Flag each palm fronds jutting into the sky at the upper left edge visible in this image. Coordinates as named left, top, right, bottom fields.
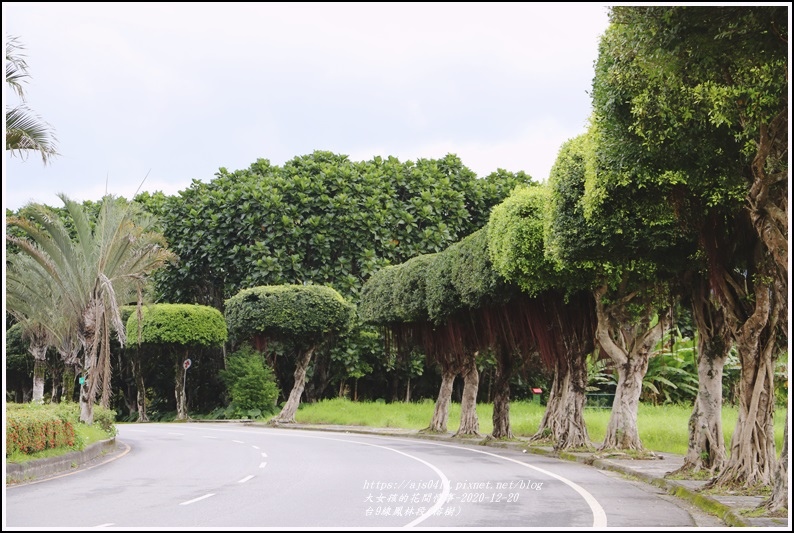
left=6, top=36, right=58, bottom=165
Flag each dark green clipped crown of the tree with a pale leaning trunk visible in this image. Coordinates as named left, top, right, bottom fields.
left=226, top=285, right=356, bottom=347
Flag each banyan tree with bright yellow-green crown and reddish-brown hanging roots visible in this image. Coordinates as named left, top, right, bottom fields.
left=487, top=187, right=596, bottom=449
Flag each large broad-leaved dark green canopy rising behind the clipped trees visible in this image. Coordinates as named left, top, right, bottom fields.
left=144, top=151, right=530, bottom=309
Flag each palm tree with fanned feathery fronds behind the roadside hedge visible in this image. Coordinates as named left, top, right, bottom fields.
left=6, top=194, right=175, bottom=424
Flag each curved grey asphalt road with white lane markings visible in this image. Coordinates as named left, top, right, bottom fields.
left=4, top=423, right=712, bottom=529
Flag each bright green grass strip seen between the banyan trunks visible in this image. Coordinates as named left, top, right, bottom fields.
left=295, top=398, right=786, bottom=455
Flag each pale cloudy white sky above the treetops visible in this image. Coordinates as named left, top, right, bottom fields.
left=2, top=2, right=608, bottom=210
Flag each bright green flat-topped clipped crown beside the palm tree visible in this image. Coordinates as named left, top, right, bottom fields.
left=127, top=304, right=228, bottom=346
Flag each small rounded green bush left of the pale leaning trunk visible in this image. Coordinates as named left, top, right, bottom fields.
left=220, top=344, right=279, bottom=418
